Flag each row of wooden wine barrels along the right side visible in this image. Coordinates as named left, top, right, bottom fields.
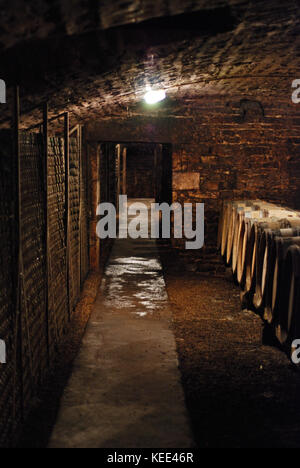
left=218, top=200, right=300, bottom=356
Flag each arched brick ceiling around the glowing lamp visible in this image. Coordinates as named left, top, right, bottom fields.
left=0, top=0, right=300, bottom=127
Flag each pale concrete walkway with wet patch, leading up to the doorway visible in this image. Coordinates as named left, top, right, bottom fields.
left=49, top=199, right=193, bottom=448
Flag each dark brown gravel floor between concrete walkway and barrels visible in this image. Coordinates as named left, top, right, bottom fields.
left=161, top=243, right=300, bottom=448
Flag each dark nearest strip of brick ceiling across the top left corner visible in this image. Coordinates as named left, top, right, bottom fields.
left=0, top=0, right=242, bottom=48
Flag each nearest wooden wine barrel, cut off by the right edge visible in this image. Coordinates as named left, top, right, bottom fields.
left=276, top=243, right=300, bottom=346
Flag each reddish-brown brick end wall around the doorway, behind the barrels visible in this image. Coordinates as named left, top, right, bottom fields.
left=87, top=94, right=300, bottom=252
